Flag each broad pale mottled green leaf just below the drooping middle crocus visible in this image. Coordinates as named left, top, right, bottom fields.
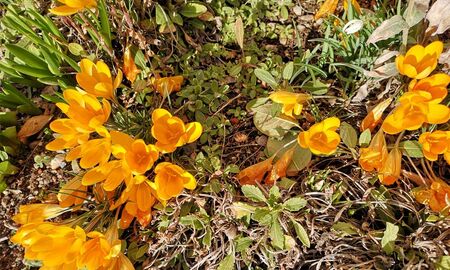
left=252, top=104, right=298, bottom=138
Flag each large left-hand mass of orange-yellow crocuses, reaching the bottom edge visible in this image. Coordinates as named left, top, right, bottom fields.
left=13, top=59, right=202, bottom=270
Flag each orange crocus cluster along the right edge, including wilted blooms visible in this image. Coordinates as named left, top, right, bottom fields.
left=359, top=41, right=450, bottom=211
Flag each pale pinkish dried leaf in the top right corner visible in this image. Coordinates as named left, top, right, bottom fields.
left=426, top=0, right=450, bottom=35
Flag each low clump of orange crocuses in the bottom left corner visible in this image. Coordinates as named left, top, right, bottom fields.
left=11, top=220, right=134, bottom=270
